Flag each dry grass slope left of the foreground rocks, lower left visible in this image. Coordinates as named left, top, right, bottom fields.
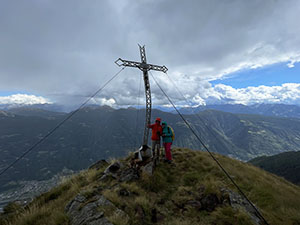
left=0, top=170, right=105, bottom=225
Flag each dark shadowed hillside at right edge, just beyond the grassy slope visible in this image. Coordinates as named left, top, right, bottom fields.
left=249, top=152, right=300, bottom=185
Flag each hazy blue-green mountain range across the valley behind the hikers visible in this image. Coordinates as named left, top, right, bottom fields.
left=0, top=106, right=300, bottom=191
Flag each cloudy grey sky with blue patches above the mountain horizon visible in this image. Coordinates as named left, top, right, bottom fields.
left=0, top=0, right=300, bottom=106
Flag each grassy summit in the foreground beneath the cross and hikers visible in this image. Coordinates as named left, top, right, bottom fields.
left=0, top=149, right=300, bottom=225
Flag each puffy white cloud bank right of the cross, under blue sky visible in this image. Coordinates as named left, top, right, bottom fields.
left=152, top=78, right=300, bottom=106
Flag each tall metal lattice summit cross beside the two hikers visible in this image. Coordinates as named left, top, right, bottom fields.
left=115, top=45, right=168, bottom=146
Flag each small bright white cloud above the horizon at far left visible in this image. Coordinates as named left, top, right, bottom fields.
left=0, top=94, right=52, bottom=105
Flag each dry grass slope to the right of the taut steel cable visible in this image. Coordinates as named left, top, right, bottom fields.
left=214, top=153, right=300, bottom=224
